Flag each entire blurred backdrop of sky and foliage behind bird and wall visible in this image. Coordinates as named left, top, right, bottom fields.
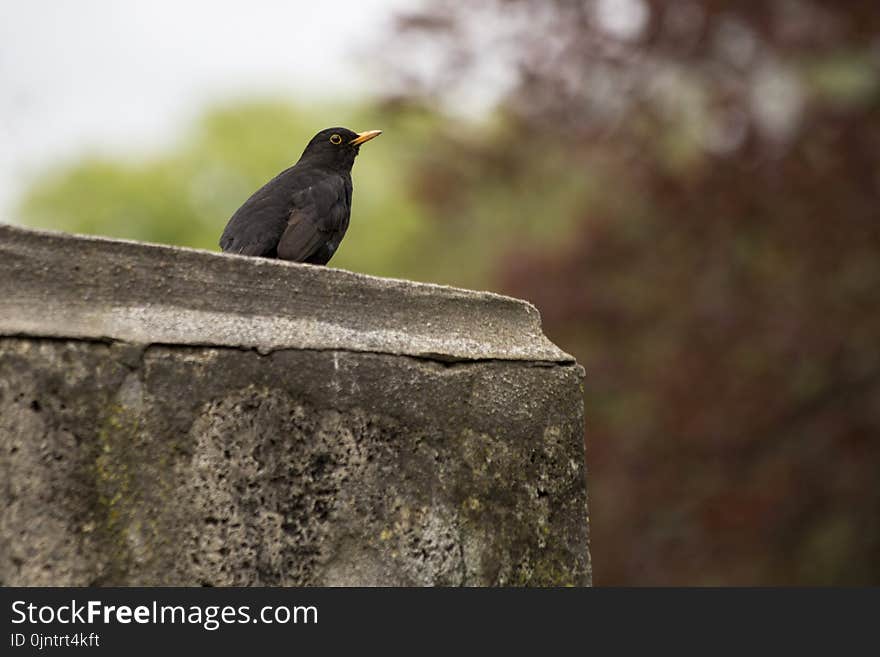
left=0, top=0, right=880, bottom=585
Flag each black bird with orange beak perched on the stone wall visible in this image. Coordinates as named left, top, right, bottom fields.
left=220, top=128, right=382, bottom=265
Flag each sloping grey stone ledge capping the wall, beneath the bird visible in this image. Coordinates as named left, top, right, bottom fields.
left=0, top=225, right=574, bottom=364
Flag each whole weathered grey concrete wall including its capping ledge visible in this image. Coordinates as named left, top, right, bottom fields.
left=0, top=226, right=590, bottom=585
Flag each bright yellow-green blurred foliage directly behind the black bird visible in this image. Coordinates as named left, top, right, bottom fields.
left=20, top=102, right=438, bottom=276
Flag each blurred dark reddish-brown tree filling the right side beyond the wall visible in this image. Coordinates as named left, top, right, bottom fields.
left=387, top=0, right=880, bottom=584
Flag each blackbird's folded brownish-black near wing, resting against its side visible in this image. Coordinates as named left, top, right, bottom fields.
left=278, top=177, right=348, bottom=262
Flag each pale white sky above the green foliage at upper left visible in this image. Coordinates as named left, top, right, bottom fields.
left=0, top=0, right=419, bottom=221
